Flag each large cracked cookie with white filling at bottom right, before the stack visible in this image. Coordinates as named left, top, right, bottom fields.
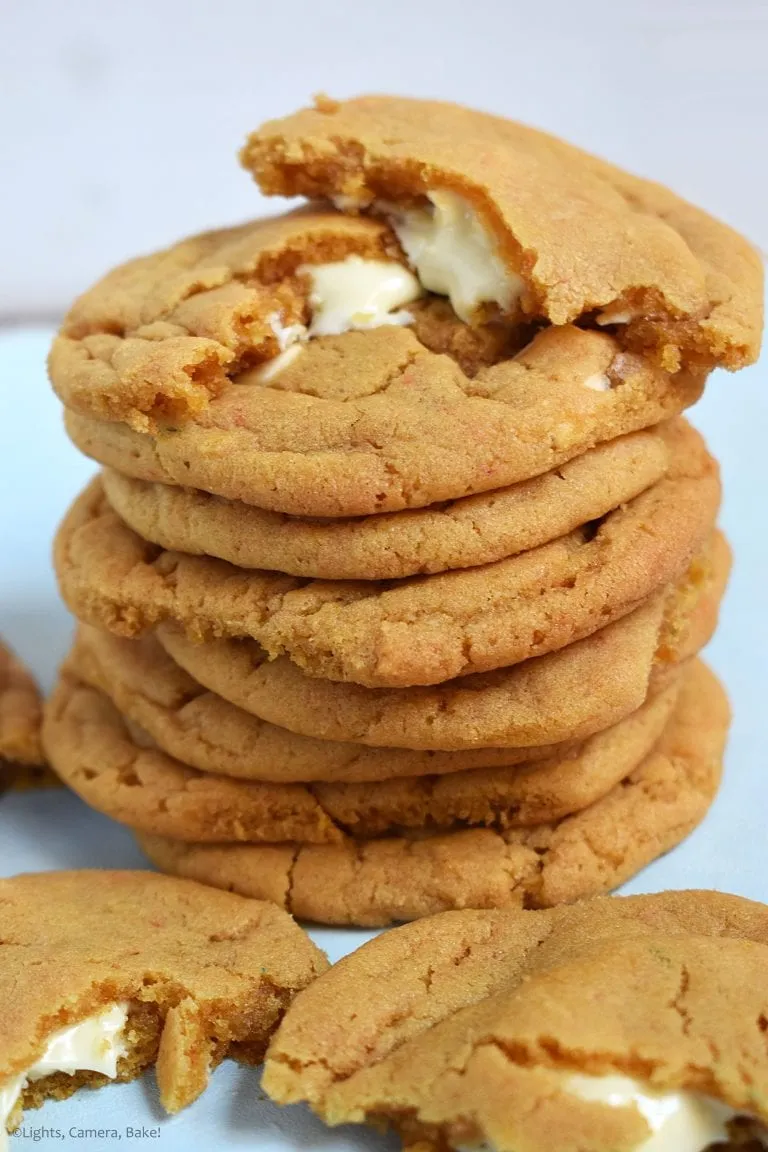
left=264, top=892, right=768, bottom=1152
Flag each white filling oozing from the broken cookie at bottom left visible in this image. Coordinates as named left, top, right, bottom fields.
left=0, top=1005, right=128, bottom=1152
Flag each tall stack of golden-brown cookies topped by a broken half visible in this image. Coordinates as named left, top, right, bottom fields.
left=44, top=98, right=761, bottom=924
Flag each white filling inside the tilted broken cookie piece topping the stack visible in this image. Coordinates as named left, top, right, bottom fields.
left=379, top=190, right=524, bottom=323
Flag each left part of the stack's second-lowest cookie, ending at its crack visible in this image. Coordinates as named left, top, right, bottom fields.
left=43, top=667, right=342, bottom=843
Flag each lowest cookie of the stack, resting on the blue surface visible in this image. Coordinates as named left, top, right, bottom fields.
left=139, top=665, right=729, bottom=926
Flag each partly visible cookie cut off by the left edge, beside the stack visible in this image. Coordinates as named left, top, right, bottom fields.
left=0, top=643, right=58, bottom=791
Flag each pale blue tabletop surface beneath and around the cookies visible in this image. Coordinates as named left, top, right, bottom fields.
left=0, top=331, right=768, bottom=1152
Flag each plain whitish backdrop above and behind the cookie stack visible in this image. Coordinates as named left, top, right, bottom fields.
left=0, top=0, right=768, bottom=320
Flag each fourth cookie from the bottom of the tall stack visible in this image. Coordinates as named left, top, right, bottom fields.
left=157, top=535, right=730, bottom=751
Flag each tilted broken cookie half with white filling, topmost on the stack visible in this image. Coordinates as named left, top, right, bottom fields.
left=241, top=96, right=762, bottom=367
